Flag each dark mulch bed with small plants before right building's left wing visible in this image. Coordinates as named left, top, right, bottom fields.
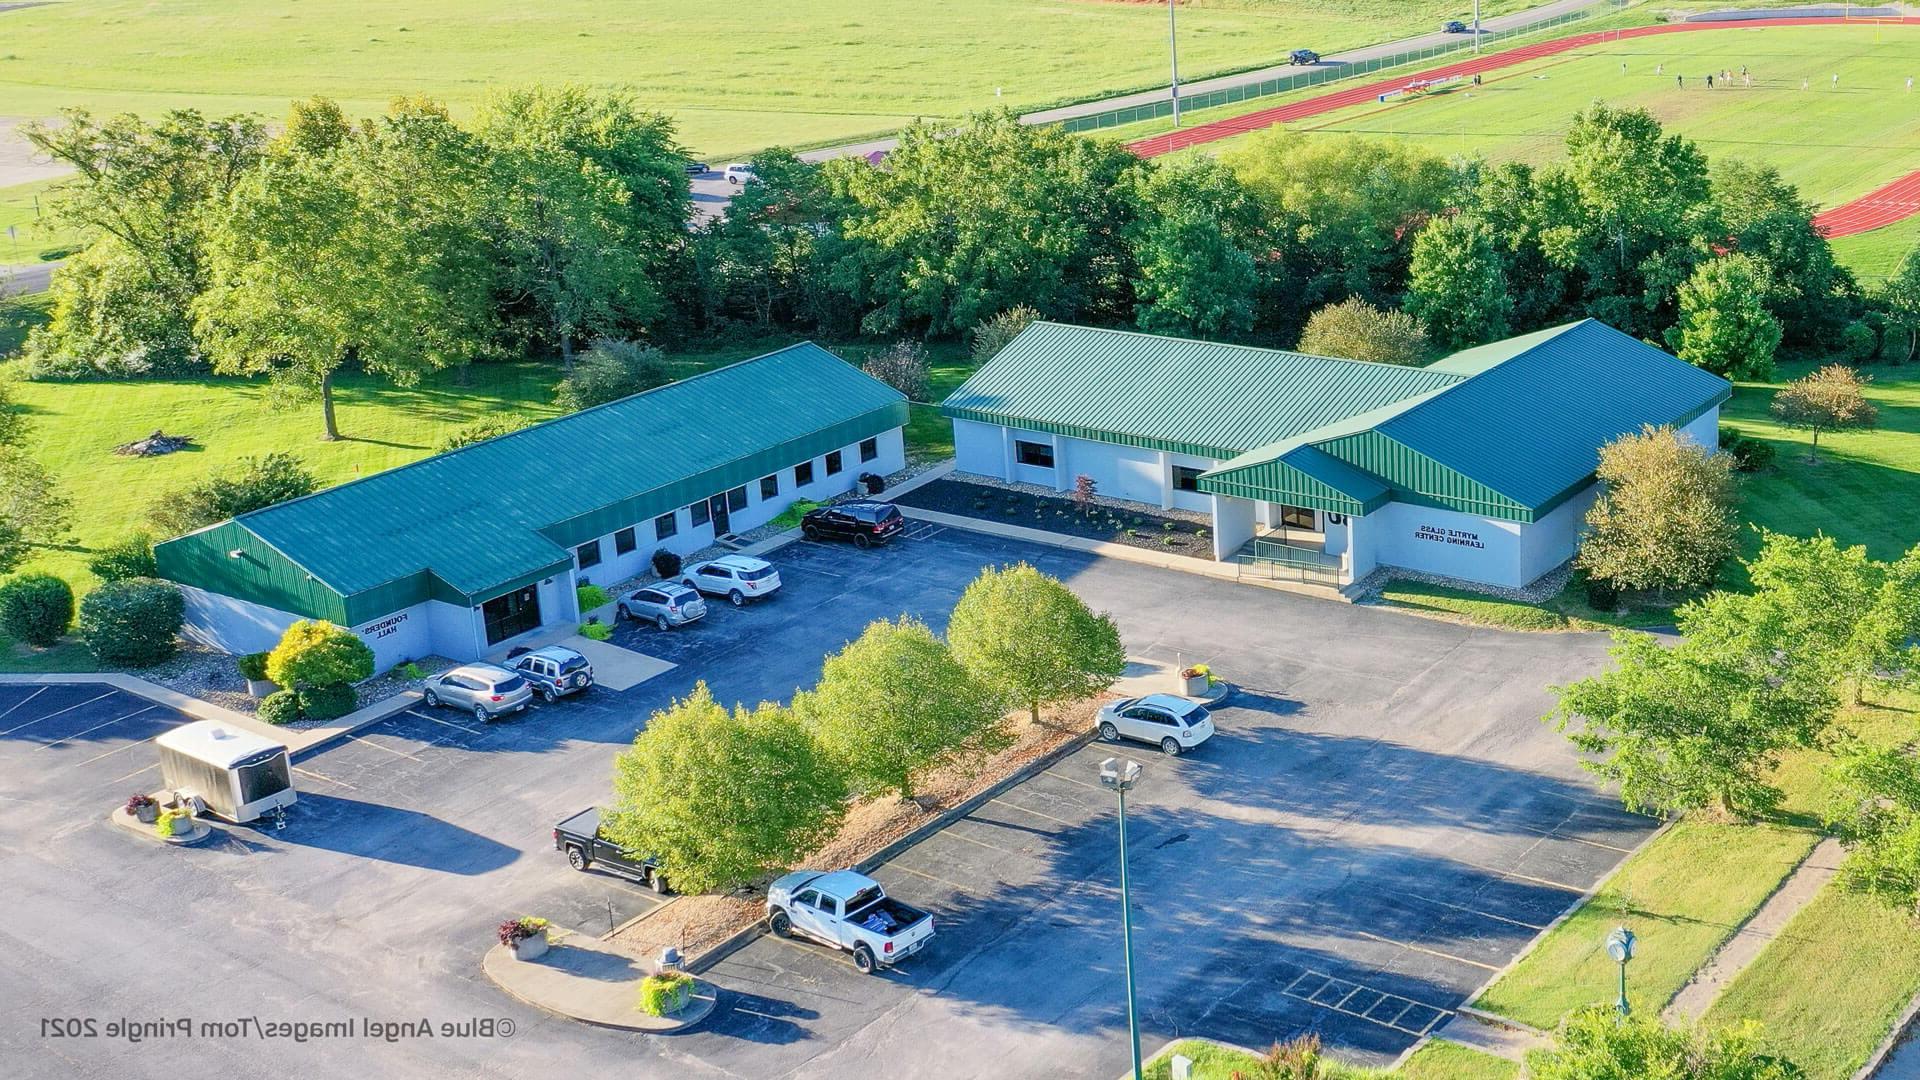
left=893, top=479, right=1213, bottom=559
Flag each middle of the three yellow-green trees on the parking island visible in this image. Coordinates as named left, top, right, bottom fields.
left=793, top=615, right=1008, bottom=799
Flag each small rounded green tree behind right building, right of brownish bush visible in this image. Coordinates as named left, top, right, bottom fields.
left=1405, top=213, right=1513, bottom=350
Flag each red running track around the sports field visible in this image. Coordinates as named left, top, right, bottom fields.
left=1127, top=15, right=1920, bottom=236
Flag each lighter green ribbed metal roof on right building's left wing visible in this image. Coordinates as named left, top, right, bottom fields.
left=941, top=323, right=1461, bottom=457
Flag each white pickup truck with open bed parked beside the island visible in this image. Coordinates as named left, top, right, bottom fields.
left=766, top=871, right=933, bottom=974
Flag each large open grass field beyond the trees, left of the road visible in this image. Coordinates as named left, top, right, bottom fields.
left=0, top=0, right=1526, bottom=156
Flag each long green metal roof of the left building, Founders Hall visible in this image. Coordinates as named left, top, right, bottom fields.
left=161, top=342, right=906, bottom=621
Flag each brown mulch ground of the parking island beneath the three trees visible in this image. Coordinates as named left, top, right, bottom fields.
left=614, top=698, right=1106, bottom=959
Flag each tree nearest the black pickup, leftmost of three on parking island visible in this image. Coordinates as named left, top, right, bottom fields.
left=601, top=682, right=847, bottom=892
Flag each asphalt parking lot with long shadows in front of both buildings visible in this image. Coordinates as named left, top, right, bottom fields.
left=0, top=527, right=1649, bottom=1078
